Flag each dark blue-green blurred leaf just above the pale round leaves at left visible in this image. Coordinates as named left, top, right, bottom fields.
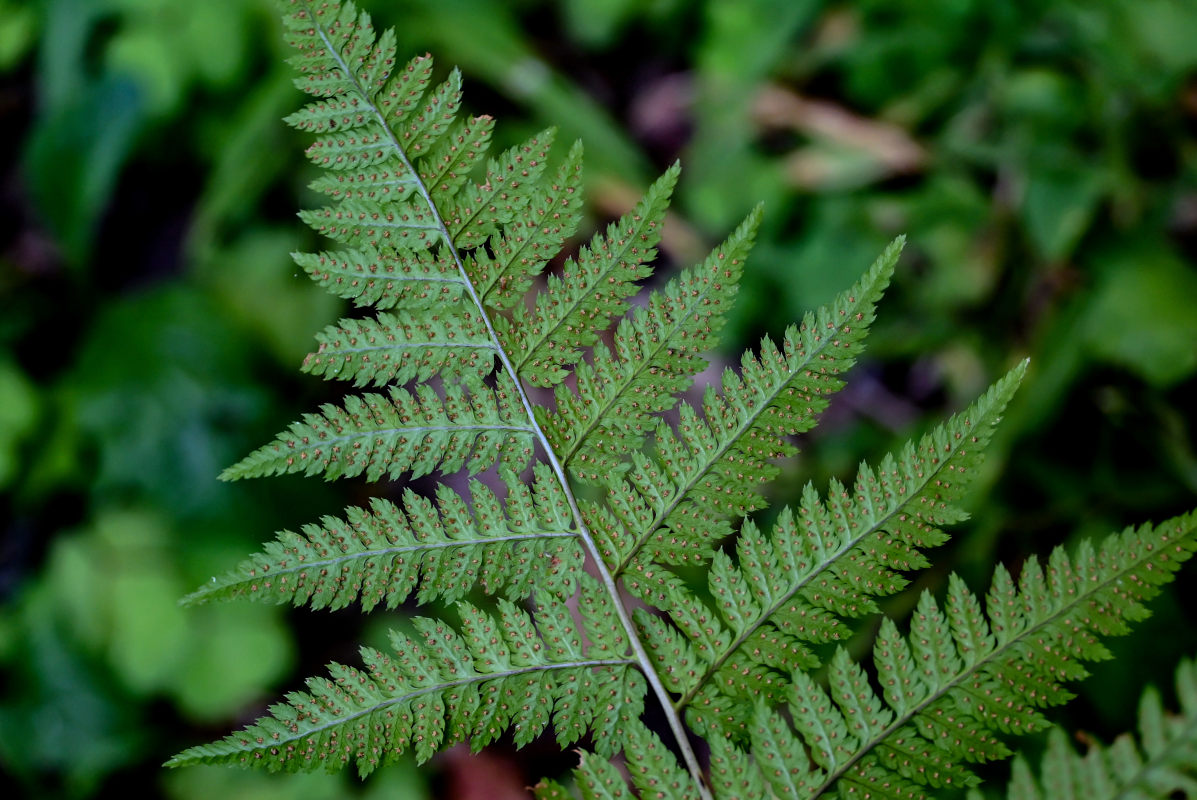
left=63, top=286, right=265, bottom=515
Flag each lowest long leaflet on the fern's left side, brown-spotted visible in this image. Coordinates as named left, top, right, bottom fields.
left=169, top=581, right=645, bottom=775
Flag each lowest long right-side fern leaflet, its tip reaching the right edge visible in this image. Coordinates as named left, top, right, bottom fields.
left=703, top=513, right=1197, bottom=798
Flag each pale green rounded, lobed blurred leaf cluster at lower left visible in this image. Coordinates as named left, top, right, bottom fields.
left=19, top=509, right=294, bottom=721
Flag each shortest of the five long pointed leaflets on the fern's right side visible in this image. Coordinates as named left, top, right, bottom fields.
left=496, top=164, right=679, bottom=386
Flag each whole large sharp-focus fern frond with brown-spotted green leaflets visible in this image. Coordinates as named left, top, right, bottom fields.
left=170, top=0, right=1197, bottom=798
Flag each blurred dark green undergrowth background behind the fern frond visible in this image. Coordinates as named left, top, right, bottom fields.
left=0, top=0, right=1197, bottom=800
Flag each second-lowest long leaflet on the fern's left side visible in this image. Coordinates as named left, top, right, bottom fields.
left=184, top=465, right=583, bottom=611
